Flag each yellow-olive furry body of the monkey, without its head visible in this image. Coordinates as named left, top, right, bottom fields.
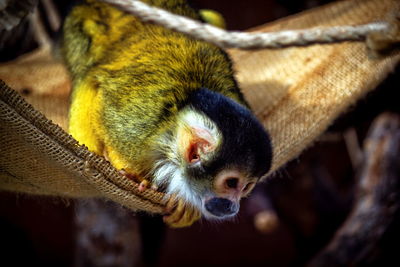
left=62, top=0, right=244, bottom=176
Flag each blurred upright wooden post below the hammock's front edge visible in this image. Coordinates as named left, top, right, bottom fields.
left=74, top=199, right=142, bottom=267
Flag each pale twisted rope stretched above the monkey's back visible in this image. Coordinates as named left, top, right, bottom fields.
left=103, top=0, right=390, bottom=49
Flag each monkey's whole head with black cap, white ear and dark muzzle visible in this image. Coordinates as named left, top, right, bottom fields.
left=152, top=88, right=272, bottom=218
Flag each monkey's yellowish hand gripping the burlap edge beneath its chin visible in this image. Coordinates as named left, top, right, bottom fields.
left=164, top=196, right=201, bottom=228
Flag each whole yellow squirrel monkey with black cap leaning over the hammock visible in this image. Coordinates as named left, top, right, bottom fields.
left=62, top=0, right=272, bottom=227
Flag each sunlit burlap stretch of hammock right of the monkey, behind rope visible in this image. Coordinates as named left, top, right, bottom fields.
left=229, top=0, right=400, bottom=175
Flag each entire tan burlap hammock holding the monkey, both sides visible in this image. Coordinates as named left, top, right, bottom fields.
left=0, top=0, right=400, bottom=213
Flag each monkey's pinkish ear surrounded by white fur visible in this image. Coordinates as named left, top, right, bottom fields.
left=178, top=126, right=216, bottom=163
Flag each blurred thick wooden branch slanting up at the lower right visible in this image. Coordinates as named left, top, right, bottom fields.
left=308, top=114, right=400, bottom=267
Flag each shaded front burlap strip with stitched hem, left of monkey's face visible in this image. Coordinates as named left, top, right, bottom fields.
left=0, top=82, right=166, bottom=213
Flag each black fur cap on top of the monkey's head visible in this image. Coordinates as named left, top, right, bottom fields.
left=189, top=88, right=272, bottom=177
